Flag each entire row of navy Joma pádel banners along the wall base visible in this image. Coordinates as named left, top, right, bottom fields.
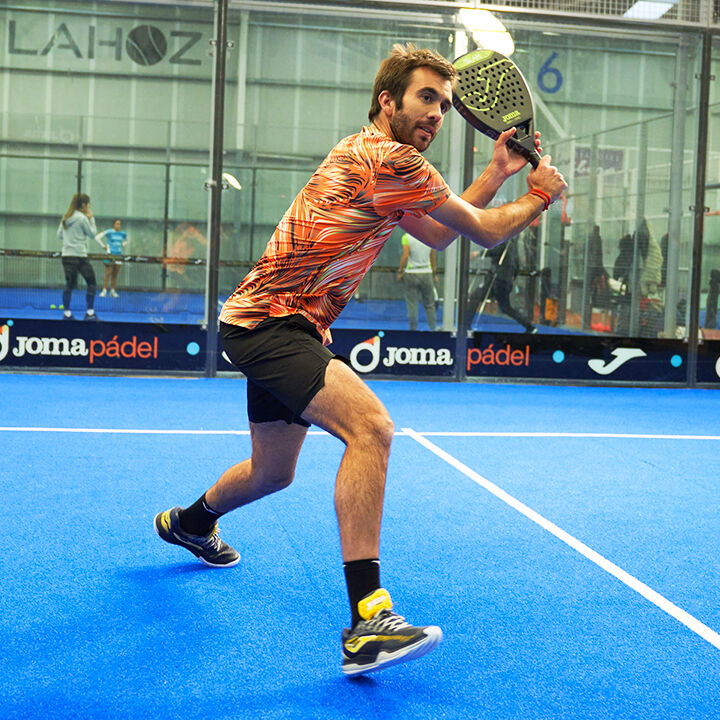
left=0, top=319, right=704, bottom=385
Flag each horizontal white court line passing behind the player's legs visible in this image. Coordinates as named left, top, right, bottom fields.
left=0, top=425, right=720, bottom=440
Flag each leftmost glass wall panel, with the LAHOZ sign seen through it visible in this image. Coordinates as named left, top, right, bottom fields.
left=0, top=0, right=213, bottom=323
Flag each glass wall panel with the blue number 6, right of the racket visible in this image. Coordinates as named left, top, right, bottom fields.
left=458, top=23, right=699, bottom=338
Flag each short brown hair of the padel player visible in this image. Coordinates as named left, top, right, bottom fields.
left=368, top=43, right=457, bottom=122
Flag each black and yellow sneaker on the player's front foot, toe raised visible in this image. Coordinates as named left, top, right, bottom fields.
left=342, top=588, right=442, bottom=675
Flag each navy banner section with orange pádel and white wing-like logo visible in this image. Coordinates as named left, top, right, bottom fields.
left=465, top=333, right=687, bottom=384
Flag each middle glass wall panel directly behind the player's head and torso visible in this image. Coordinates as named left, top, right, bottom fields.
left=220, top=12, right=462, bottom=330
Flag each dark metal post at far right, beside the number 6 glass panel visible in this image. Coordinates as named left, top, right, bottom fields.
left=687, top=30, right=713, bottom=387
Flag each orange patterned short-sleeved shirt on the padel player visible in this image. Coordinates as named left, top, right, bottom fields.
left=220, top=127, right=450, bottom=344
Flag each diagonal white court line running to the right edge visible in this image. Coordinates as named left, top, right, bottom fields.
left=403, top=428, right=720, bottom=650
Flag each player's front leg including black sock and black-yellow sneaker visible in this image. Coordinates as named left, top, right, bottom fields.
left=303, top=360, right=442, bottom=676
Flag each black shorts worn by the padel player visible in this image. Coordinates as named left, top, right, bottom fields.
left=219, top=315, right=335, bottom=427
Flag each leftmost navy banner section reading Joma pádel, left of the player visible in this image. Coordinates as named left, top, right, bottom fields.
left=0, top=319, right=206, bottom=371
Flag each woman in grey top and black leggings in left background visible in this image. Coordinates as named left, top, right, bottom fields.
left=58, top=193, right=98, bottom=320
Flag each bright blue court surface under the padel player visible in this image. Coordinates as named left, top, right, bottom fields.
left=0, top=374, right=720, bottom=720
